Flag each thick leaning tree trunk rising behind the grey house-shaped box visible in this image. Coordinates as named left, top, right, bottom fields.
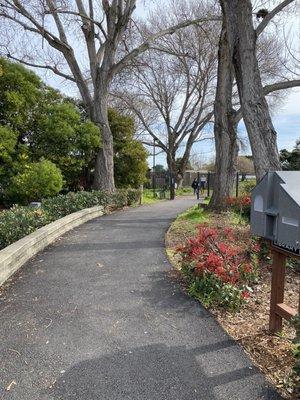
left=220, top=0, right=281, bottom=179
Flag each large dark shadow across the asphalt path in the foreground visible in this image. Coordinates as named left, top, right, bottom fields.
left=49, top=340, right=277, bottom=400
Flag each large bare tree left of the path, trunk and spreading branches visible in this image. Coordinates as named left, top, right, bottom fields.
left=0, top=0, right=220, bottom=191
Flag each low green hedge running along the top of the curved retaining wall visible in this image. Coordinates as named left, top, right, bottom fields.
left=0, top=189, right=141, bottom=249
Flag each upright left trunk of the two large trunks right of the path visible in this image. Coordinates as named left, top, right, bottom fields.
left=209, top=22, right=238, bottom=211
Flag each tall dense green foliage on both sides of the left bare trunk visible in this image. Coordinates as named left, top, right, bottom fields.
left=0, top=58, right=148, bottom=205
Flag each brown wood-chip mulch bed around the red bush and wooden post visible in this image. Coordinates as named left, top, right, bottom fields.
left=166, top=214, right=300, bottom=399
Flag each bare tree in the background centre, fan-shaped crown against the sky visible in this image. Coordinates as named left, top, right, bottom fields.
left=115, top=3, right=218, bottom=198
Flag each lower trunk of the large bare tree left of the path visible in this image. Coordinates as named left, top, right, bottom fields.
left=93, top=88, right=115, bottom=193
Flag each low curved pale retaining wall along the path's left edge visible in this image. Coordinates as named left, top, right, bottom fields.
left=0, top=206, right=103, bottom=286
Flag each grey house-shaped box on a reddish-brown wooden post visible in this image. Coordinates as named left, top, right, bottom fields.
left=251, top=171, right=300, bottom=333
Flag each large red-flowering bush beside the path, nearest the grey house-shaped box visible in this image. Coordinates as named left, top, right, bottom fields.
left=178, top=225, right=259, bottom=309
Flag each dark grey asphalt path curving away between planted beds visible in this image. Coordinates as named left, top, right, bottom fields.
left=0, top=199, right=280, bottom=400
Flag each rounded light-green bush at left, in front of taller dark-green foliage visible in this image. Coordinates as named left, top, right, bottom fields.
left=8, top=160, right=63, bottom=204
